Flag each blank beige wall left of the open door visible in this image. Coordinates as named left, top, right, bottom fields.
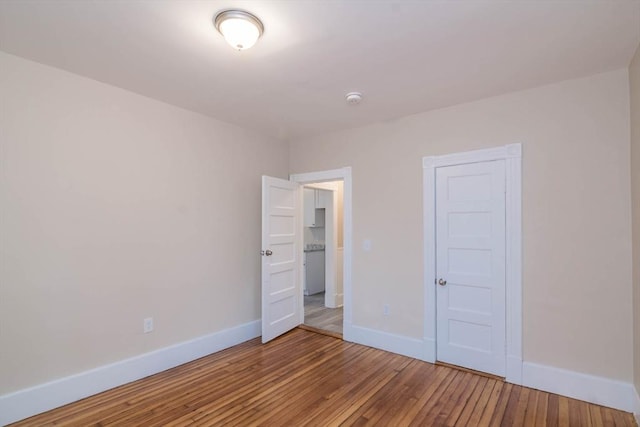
left=0, top=53, right=288, bottom=395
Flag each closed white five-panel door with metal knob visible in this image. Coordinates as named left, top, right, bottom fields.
left=436, top=160, right=506, bottom=376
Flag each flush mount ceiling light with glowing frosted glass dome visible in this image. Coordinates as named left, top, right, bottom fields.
left=213, top=10, right=264, bottom=50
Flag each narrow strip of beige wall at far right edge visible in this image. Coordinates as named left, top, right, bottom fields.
left=629, top=47, right=640, bottom=406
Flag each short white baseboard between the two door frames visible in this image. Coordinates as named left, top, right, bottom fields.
left=343, top=325, right=426, bottom=360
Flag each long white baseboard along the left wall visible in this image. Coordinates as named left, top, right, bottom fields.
left=0, top=320, right=261, bottom=425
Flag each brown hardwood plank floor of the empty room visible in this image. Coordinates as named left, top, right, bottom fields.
left=15, top=329, right=636, bottom=426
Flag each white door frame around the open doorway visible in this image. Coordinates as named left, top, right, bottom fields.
left=289, top=167, right=353, bottom=341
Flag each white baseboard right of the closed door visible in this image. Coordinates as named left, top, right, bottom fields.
left=522, top=362, right=637, bottom=412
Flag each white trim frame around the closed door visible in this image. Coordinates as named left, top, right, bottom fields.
left=422, top=144, right=522, bottom=384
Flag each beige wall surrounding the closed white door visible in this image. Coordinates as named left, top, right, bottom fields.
left=290, top=70, right=633, bottom=382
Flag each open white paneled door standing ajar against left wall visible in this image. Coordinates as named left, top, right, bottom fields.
left=262, top=176, right=302, bottom=343
